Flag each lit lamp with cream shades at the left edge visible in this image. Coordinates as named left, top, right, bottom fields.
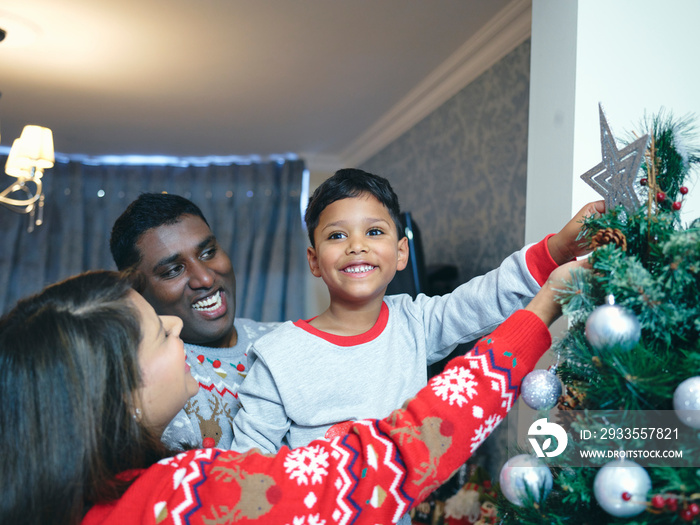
left=0, top=126, right=54, bottom=232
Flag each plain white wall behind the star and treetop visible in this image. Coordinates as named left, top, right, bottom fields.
left=525, top=0, right=700, bottom=242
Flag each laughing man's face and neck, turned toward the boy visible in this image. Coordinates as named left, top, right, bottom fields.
left=136, top=215, right=238, bottom=348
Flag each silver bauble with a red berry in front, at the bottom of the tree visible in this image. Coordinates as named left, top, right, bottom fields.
left=593, top=459, right=651, bottom=518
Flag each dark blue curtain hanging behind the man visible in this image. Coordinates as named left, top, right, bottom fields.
left=0, top=159, right=308, bottom=321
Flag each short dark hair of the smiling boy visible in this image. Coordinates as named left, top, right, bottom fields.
left=304, top=168, right=403, bottom=247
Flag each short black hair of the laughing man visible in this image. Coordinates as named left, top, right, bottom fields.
left=109, top=193, right=209, bottom=270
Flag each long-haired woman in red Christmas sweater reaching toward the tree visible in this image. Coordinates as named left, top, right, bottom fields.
left=0, top=265, right=569, bottom=524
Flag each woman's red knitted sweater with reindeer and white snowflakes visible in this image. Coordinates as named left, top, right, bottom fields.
left=83, top=310, right=551, bottom=525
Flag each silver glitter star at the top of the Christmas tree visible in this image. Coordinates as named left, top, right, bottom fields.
left=581, top=104, right=649, bottom=213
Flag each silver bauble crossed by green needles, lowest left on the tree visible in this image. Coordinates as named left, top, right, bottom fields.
left=499, top=454, right=553, bottom=507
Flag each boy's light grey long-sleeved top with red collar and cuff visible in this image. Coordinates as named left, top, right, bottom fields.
left=232, top=241, right=556, bottom=452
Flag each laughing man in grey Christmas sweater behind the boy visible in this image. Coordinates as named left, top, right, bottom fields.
left=110, top=193, right=277, bottom=448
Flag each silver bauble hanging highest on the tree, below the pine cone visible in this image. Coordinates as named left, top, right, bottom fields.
left=586, top=295, right=642, bottom=351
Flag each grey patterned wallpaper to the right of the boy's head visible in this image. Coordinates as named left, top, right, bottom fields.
left=360, top=40, right=530, bottom=282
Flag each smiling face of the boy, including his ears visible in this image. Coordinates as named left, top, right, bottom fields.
left=307, top=193, right=408, bottom=305
